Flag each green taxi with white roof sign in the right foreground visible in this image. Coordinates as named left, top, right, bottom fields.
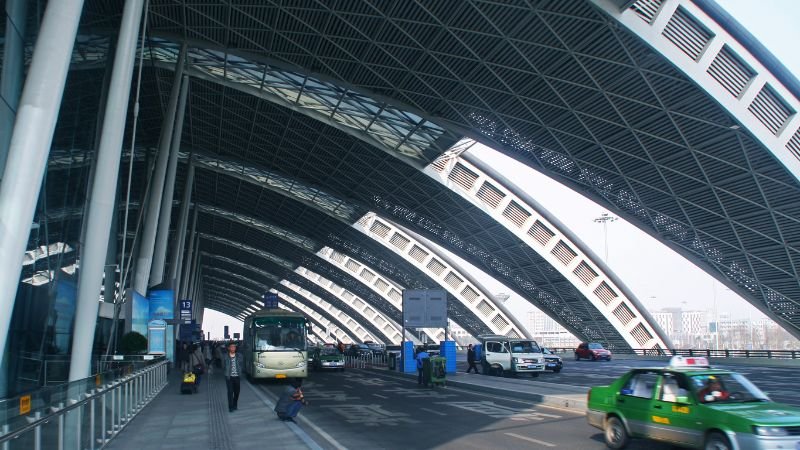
left=586, top=356, right=800, bottom=450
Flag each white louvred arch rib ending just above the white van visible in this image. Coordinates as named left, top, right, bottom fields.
left=353, top=212, right=530, bottom=337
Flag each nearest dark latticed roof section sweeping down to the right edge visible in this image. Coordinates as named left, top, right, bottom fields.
left=133, top=0, right=800, bottom=336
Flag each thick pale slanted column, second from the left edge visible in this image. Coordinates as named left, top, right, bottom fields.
left=69, top=0, right=144, bottom=381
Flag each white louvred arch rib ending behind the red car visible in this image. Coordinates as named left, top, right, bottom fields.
left=424, top=146, right=667, bottom=349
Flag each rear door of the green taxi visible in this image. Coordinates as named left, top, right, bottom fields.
left=617, top=370, right=659, bottom=437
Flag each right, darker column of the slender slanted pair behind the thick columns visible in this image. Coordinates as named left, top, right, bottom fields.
left=148, top=76, right=191, bottom=286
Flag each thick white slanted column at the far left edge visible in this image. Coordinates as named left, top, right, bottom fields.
left=0, top=0, right=83, bottom=364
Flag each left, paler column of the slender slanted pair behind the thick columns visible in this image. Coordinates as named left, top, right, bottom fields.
left=133, top=44, right=186, bottom=295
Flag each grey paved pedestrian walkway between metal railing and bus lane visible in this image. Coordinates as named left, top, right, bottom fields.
left=106, top=370, right=313, bottom=450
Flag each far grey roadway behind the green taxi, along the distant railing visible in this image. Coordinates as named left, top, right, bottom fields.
left=456, top=354, right=800, bottom=406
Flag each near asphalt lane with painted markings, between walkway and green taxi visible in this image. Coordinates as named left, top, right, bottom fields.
left=257, top=369, right=671, bottom=450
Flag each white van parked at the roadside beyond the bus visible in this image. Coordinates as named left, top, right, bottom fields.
left=478, top=335, right=544, bottom=377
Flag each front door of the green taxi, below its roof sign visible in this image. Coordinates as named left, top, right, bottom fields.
left=650, top=372, right=703, bottom=446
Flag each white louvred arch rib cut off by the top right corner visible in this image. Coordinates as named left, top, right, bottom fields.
left=591, top=0, right=800, bottom=184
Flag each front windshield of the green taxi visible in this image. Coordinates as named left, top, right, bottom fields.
left=690, top=373, right=769, bottom=404
